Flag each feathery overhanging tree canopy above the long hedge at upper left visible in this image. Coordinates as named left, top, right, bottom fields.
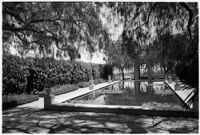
left=3, top=2, right=105, bottom=59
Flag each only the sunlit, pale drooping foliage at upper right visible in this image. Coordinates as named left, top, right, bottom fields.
left=98, top=2, right=198, bottom=57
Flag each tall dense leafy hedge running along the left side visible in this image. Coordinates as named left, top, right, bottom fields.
left=3, top=54, right=104, bottom=95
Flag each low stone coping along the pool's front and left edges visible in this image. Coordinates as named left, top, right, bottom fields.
left=45, top=81, right=198, bottom=118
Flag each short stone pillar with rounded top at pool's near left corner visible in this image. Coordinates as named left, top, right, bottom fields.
left=44, top=88, right=55, bottom=109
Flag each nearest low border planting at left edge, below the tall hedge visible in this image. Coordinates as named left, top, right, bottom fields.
left=2, top=94, right=39, bottom=110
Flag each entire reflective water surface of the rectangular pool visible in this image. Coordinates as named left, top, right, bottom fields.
left=67, top=81, right=183, bottom=109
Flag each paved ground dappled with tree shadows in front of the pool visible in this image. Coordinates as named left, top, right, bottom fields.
left=3, top=108, right=198, bottom=133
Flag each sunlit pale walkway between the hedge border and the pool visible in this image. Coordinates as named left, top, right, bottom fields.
left=18, top=81, right=119, bottom=109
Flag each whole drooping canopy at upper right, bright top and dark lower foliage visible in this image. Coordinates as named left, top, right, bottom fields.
left=98, top=2, right=198, bottom=81
